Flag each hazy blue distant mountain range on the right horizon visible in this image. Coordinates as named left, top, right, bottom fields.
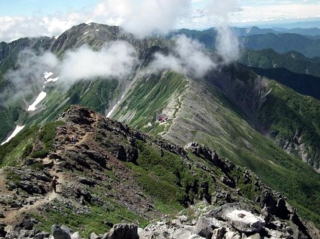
left=173, top=27, right=320, bottom=57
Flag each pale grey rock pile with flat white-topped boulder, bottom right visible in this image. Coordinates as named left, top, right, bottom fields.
left=139, top=204, right=309, bottom=239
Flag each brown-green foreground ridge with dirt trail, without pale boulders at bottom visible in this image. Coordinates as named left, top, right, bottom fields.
left=0, top=106, right=316, bottom=238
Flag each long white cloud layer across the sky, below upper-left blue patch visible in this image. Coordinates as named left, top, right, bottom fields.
left=0, top=0, right=320, bottom=41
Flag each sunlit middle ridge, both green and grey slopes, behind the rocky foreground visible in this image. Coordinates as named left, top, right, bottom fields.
left=113, top=67, right=320, bottom=226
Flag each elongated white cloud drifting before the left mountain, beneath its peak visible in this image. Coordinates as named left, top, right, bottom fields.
left=5, top=41, right=138, bottom=97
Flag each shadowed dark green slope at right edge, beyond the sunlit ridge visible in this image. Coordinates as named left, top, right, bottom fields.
left=259, top=82, right=320, bottom=168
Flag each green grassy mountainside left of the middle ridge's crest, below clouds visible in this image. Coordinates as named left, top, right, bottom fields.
left=114, top=72, right=187, bottom=134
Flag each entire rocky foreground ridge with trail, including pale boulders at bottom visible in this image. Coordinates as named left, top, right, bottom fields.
left=0, top=106, right=320, bottom=239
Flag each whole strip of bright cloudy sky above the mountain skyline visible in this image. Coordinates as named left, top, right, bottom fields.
left=0, top=0, right=320, bottom=41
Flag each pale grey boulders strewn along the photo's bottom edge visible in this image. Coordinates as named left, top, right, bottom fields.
left=2, top=203, right=316, bottom=239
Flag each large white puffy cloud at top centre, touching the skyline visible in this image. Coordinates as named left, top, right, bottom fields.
left=94, top=0, right=191, bottom=37
